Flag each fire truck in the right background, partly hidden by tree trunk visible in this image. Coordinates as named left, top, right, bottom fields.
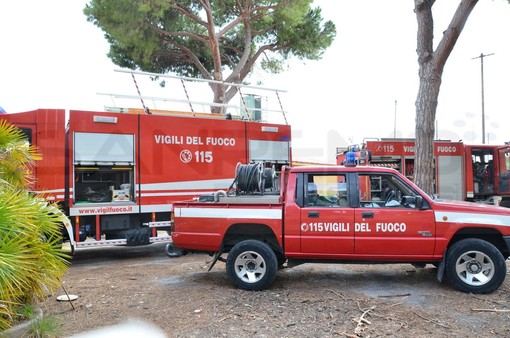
left=337, top=138, right=510, bottom=207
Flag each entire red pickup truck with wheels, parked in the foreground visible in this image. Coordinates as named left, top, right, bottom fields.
left=172, top=162, right=510, bottom=293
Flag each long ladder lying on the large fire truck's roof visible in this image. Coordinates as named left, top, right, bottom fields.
left=97, top=69, right=288, bottom=124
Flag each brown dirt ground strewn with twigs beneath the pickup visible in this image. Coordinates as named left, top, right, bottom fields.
left=42, top=243, right=510, bottom=338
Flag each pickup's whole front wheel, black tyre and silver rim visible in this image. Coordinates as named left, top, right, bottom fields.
left=446, top=238, right=506, bottom=294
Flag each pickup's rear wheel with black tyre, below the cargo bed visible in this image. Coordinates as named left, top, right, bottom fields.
left=227, top=239, right=278, bottom=291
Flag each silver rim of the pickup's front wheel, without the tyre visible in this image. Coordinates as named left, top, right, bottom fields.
left=455, top=251, right=495, bottom=286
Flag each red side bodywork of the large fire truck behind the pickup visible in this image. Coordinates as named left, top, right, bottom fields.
left=2, top=109, right=290, bottom=207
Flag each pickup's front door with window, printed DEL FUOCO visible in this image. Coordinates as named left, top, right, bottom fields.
left=354, top=173, right=436, bottom=259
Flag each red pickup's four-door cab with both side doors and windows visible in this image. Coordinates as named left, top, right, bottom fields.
left=285, top=167, right=434, bottom=262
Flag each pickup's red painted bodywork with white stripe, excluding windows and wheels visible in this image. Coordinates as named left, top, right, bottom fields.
left=172, top=166, right=510, bottom=262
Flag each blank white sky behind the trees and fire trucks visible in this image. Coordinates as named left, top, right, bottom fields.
left=0, top=0, right=510, bottom=163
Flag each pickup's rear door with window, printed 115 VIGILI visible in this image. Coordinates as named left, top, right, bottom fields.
left=298, top=173, right=354, bottom=257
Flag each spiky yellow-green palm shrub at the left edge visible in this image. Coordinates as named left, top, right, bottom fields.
left=0, top=121, right=68, bottom=332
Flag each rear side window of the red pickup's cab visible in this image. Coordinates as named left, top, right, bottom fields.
left=305, top=174, right=350, bottom=208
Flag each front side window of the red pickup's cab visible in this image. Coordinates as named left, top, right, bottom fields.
left=359, top=174, right=416, bottom=208
